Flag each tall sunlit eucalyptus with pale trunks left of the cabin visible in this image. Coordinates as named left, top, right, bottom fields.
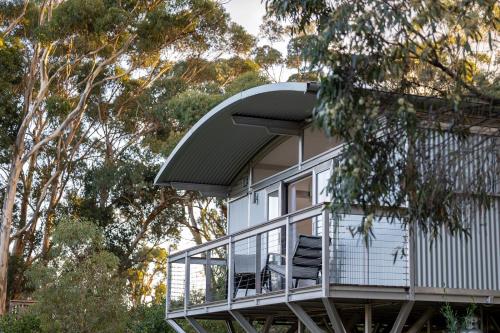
left=0, top=0, right=258, bottom=313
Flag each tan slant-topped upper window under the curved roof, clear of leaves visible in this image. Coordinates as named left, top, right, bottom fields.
left=252, top=136, right=299, bottom=183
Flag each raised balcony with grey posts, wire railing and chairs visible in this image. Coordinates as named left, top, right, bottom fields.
left=167, top=204, right=410, bottom=319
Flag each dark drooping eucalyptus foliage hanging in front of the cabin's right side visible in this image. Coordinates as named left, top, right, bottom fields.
left=266, top=0, right=500, bottom=239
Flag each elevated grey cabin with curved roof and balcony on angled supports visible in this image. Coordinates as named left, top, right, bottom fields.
left=156, top=83, right=500, bottom=333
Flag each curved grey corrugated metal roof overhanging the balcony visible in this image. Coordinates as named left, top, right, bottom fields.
left=155, top=83, right=316, bottom=194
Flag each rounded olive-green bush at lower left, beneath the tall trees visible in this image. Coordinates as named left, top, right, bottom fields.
left=28, top=218, right=127, bottom=332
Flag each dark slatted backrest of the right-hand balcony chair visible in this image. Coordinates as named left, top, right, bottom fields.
left=292, top=235, right=323, bottom=271
